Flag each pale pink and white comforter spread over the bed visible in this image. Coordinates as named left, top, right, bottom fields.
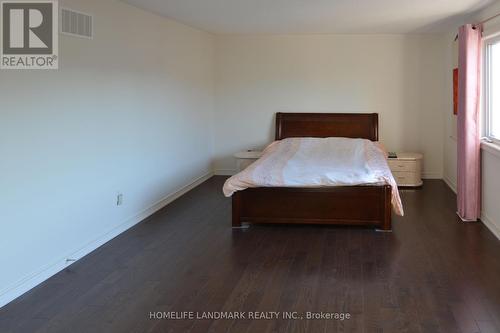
left=224, top=138, right=403, bottom=216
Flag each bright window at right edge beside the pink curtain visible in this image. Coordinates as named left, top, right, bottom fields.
left=484, top=37, right=500, bottom=143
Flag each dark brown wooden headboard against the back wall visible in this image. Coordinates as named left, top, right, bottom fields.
left=276, top=113, right=378, bottom=141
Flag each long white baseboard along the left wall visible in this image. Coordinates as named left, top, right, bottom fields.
left=0, top=172, right=213, bottom=307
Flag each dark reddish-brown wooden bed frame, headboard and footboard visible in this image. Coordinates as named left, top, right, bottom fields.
left=232, top=113, right=392, bottom=231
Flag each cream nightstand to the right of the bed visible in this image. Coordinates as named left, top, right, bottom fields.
left=388, top=153, right=424, bottom=187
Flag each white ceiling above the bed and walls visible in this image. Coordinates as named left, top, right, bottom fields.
left=122, top=0, right=495, bottom=34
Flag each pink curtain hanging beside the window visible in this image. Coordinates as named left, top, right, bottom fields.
left=457, top=24, right=482, bottom=221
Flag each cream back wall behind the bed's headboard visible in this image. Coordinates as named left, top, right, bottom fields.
left=215, top=35, right=446, bottom=178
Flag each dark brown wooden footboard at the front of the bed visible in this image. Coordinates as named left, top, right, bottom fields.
left=232, top=185, right=392, bottom=231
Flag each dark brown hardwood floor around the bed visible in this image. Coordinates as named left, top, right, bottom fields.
left=0, top=177, right=500, bottom=333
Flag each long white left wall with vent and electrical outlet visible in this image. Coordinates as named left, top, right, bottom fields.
left=0, top=0, right=214, bottom=306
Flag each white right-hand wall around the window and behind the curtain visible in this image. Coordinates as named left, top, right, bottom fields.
left=444, top=2, right=500, bottom=238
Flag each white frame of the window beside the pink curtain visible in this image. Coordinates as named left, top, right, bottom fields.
left=482, top=34, right=500, bottom=145
